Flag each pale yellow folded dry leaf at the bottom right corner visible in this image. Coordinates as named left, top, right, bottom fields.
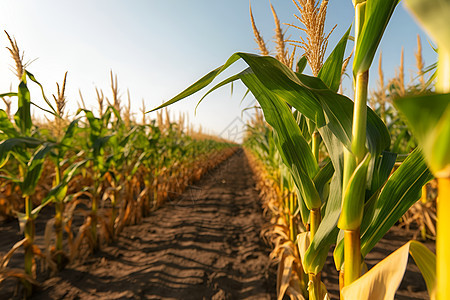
left=341, top=241, right=436, bottom=300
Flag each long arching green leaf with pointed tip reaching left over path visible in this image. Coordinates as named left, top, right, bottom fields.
left=152, top=53, right=390, bottom=154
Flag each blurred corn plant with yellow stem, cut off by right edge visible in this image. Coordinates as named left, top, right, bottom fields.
left=395, top=0, right=450, bottom=299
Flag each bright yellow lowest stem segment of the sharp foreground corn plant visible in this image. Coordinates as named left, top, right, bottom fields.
left=344, top=229, right=361, bottom=286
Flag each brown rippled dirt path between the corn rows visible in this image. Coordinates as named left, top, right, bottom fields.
left=33, top=150, right=276, bottom=300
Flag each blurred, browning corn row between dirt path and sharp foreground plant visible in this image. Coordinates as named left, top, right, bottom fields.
left=244, top=111, right=309, bottom=297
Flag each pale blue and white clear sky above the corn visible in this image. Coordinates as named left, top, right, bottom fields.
left=0, top=0, right=437, bottom=141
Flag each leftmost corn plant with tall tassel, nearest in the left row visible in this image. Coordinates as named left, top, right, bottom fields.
left=0, top=35, right=55, bottom=295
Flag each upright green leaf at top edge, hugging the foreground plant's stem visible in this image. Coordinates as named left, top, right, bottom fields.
left=353, top=0, right=399, bottom=75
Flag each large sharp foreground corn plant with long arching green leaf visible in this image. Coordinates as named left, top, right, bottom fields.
left=148, top=0, right=440, bottom=299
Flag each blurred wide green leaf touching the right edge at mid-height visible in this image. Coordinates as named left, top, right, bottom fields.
left=394, top=94, right=450, bottom=178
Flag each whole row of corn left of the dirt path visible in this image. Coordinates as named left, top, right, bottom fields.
left=0, top=36, right=236, bottom=296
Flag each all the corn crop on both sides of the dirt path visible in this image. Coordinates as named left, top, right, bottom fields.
left=0, top=0, right=450, bottom=300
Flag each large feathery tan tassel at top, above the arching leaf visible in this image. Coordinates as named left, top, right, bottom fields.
left=287, top=0, right=336, bottom=76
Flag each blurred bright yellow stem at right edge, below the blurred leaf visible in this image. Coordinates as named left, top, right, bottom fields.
left=436, top=178, right=450, bottom=300
